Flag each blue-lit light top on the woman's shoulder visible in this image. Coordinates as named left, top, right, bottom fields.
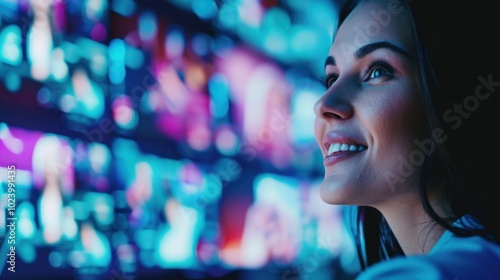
left=356, top=216, right=500, bottom=280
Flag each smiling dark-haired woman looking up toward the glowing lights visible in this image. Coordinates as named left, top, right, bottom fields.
left=314, top=0, right=500, bottom=279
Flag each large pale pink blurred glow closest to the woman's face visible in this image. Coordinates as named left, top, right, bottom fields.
left=216, top=48, right=293, bottom=168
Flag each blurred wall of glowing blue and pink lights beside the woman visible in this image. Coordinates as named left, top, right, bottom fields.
left=0, top=0, right=357, bottom=279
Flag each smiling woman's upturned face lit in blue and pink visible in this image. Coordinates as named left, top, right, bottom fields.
left=314, top=0, right=424, bottom=207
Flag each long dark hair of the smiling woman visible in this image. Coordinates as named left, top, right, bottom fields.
left=338, top=0, right=500, bottom=269
